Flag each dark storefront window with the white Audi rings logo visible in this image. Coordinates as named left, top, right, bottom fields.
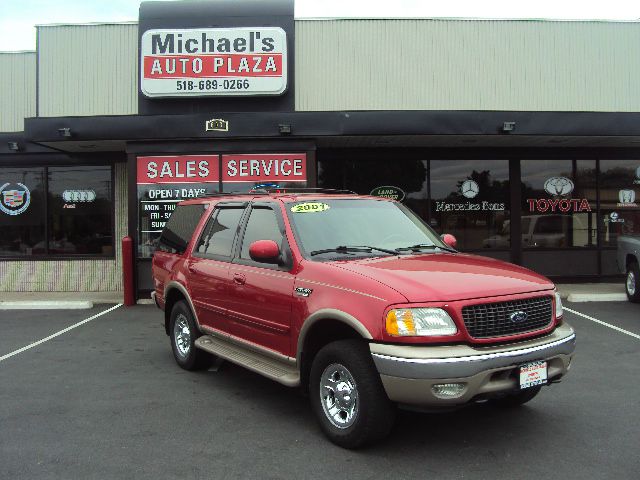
left=48, top=166, right=113, bottom=255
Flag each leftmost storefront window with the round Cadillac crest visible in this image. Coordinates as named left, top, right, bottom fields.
left=0, top=168, right=46, bottom=257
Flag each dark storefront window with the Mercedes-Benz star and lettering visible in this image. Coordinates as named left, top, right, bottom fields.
left=429, top=160, right=510, bottom=250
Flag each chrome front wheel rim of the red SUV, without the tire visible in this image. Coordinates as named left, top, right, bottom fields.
left=320, top=363, right=359, bottom=428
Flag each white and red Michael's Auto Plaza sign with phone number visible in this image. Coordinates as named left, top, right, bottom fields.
left=140, top=27, right=287, bottom=97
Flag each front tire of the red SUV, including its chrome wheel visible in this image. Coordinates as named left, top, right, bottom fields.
left=309, top=340, right=395, bottom=448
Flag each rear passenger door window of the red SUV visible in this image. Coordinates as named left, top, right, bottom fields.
left=196, top=207, right=244, bottom=257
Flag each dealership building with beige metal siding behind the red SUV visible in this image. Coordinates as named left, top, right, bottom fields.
left=0, top=0, right=640, bottom=295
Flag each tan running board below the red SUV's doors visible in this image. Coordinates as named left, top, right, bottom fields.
left=195, top=335, right=300, bottom=387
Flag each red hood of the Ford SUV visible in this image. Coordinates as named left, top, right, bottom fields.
left=331, top=253, right=553, bottom=302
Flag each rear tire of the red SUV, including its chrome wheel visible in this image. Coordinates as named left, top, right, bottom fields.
left=169, top=301, right=212, bottom=370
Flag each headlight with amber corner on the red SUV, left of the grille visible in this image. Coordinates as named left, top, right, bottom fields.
left=386, top=308, right=458, bottom=337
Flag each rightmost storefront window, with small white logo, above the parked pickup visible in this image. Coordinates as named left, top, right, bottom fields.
left=600, top=160, right=640, bottom=247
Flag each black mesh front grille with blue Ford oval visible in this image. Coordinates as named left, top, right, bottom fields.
left=462, top=297, right=553, bottom=338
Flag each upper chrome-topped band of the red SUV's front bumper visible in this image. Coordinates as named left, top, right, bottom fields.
left=371, top=332, right=576, bottom=379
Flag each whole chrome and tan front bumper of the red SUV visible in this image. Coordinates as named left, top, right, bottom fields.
left=370, top=323, right=576, bottom=407
